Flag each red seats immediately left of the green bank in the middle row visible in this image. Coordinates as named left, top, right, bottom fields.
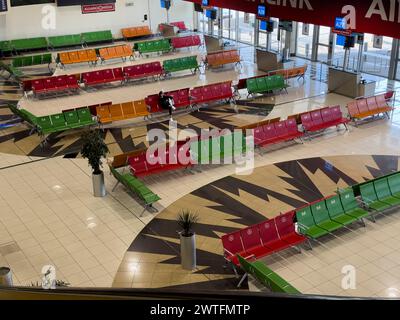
left=128, top=141, right=192, bottom=177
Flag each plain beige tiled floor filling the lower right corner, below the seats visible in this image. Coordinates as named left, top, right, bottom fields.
left=263, top=210, right=400, bottom=298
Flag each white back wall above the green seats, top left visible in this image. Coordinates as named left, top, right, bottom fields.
left=0, top=0, right=193, bottom=40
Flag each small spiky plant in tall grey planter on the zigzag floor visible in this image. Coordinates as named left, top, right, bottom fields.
left=177, top=210, right=199, bottom=270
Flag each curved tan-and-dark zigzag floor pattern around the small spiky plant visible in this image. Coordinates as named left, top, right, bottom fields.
left=113, top=155, right=400, bottom=290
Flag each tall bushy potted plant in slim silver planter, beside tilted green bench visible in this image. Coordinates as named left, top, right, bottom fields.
left=81, top=130, right=108, bottom=197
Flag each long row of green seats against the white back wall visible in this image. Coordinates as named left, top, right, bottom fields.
left=0, top=30, right=113, bottom=53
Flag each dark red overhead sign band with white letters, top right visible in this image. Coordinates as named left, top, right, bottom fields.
left=186, top=0, right=400, bottom=38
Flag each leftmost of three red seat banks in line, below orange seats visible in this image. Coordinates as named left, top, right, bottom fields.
left=32, top=75, right=79, bottom=96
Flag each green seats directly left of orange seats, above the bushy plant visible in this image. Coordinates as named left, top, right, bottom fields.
left=37, top=107, right=97, bottom=135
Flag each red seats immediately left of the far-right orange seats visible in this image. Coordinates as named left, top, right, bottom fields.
left=301, top=106, right=350, bottom=132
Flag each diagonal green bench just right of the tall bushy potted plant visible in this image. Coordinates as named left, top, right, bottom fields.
left=109, top=165, right=161, bottom=207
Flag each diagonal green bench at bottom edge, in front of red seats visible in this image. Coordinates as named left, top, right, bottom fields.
left=237, top=255, right=301, bottom=294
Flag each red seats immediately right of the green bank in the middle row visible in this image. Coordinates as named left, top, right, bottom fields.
left=253, top=119, right=304, bottom=147
